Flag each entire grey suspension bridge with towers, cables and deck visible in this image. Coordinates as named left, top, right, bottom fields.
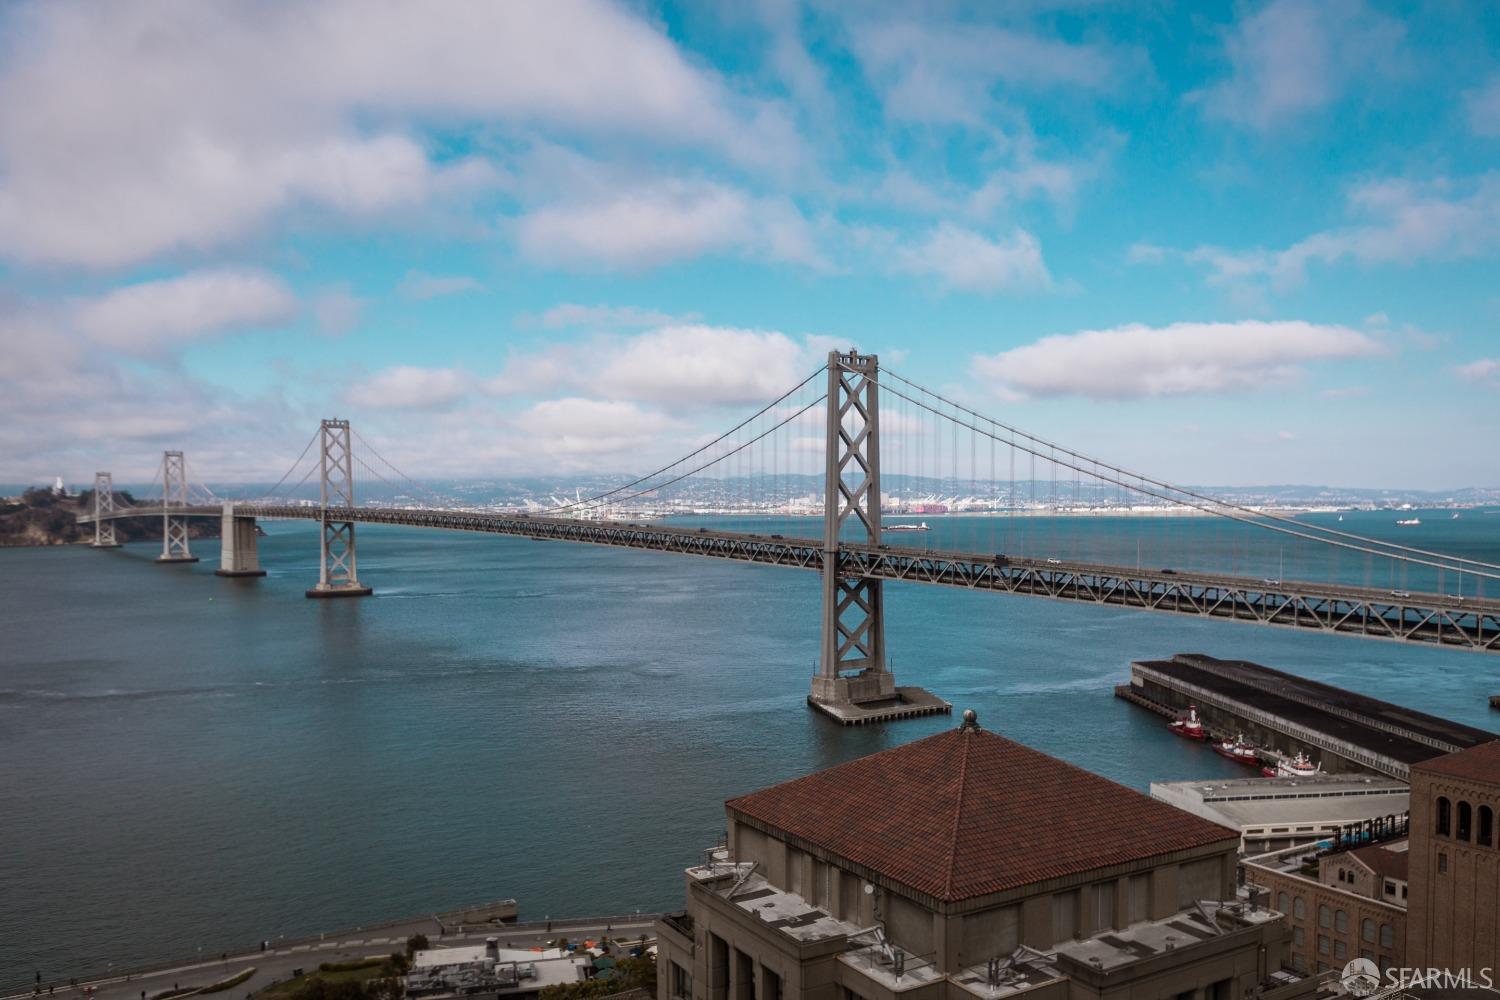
left=80, top=351, right=1500, bottom=723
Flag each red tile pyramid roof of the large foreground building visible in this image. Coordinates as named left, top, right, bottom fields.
left=726, top=729, right=1239, bottom=903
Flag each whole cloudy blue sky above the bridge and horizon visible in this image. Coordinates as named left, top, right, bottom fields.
left=0, top=0, right=1500, bottom=489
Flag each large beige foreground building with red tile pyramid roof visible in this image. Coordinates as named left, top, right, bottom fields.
left=657, top=712, right=1313, bottom=1000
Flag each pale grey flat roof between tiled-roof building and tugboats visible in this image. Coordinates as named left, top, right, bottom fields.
left=1151, top=775, right=1412, bottom=828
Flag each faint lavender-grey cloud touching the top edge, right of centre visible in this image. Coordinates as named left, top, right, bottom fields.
left=1191, top=0, right=1404, bottom=130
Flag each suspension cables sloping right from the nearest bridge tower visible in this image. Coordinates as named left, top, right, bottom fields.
left=878, top=369, right=1500, bottom=579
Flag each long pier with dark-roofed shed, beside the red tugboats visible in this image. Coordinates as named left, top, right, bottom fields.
left=1115, top=654, right=1500, bottom=781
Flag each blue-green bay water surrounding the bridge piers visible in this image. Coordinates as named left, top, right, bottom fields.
left=0, top=514, right=1500, bottom=987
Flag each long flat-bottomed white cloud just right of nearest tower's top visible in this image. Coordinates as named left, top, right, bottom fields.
left=974, top=321, right=1382, bottom=399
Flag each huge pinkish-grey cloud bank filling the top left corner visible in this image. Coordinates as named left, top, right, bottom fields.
left=0, top=0, right=801, bottom=267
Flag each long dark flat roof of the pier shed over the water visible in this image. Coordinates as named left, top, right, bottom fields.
left=1139, top=652, right=1500, bottom=765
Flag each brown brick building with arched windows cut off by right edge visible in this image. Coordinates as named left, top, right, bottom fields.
left=1407, top=741, right=1500, bottom=979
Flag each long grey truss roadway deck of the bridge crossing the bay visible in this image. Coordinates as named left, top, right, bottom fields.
left=80, top=504, right=1500, bottom=654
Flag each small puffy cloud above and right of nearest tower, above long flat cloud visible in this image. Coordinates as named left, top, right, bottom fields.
left=891, top=222, right=1052, bottom=292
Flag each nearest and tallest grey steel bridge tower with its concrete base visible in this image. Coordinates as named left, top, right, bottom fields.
left=807, top=351, right=953, bottom=726
